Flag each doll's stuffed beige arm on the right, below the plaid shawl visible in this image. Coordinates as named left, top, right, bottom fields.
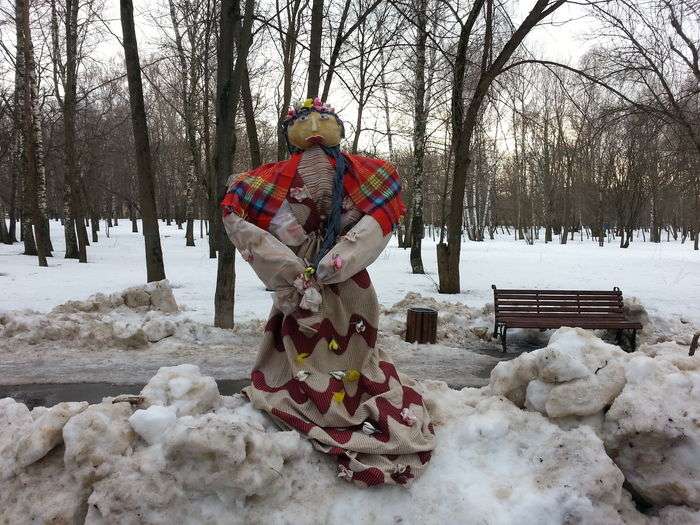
left=316, top=215, right=391, bottom=284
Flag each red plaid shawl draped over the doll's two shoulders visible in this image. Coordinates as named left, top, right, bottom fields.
left=221, top=153, right=406, bottom=235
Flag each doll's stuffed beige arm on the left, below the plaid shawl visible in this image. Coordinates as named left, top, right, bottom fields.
left=224, top=213, right=305, bottom=290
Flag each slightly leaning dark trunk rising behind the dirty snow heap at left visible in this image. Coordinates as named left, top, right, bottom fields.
left=119, top=0, right=165, bottom=282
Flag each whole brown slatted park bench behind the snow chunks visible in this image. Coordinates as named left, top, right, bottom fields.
left=491, top=284, right=642, bottom=352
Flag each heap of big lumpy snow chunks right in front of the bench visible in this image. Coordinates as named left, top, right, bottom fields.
left=489, top=328, right=700, bottom=510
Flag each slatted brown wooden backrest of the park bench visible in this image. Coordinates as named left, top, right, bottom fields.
left=491, top=285, right=624, bottom=319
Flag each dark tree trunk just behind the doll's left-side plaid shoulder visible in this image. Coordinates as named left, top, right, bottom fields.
left=212, top=0, right=254, bottom=328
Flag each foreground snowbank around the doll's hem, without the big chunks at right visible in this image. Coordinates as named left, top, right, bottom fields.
left=0, top=365, right=644, bottom=524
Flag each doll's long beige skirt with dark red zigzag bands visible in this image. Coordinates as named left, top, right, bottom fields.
left=244, top=270, right=435, bottom=486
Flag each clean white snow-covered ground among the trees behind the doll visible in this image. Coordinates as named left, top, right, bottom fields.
left=0, top=220, right=700, bottom=326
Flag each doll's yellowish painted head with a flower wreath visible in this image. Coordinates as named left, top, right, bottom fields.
left=282, top=97, right=345, bottom=152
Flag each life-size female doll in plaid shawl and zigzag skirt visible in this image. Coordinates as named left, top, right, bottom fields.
left=222, top=99, right=434, bottom=486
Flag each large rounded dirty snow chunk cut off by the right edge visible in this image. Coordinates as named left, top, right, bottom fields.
left=603, top=343, right=700, bottom=510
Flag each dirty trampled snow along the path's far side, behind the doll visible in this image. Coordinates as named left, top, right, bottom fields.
left=0, top=281, right=511, bottom=386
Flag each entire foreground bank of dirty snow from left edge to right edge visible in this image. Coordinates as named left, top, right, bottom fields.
left=0, top=328, right=700, bottom=525
